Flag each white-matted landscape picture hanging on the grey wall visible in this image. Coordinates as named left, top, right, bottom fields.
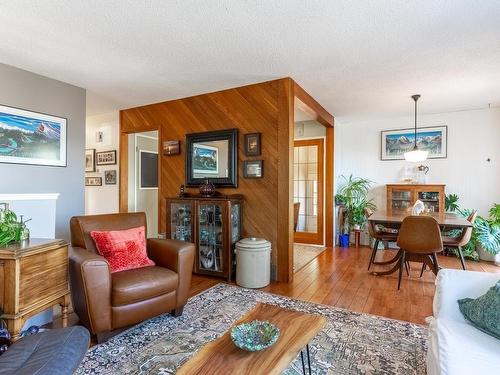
left=0, top=105, right=66, bottom=167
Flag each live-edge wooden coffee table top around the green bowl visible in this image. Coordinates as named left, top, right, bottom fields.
left=177, top=303, right=326, bottom=375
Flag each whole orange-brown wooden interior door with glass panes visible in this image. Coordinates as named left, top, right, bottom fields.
left=293, top=138, right=324, bottom=245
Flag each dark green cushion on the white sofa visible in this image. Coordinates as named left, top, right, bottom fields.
left=458, top=281, right=500, bottom=340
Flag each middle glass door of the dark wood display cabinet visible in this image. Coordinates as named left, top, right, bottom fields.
left=197, top=202, right=224, bottom=273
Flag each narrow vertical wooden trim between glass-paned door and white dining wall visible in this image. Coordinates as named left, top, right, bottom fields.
left=325, top=127, right=335, bottom=247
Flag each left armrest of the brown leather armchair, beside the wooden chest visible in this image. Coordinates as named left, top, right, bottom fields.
left=69, top=247, right=112, bottom=334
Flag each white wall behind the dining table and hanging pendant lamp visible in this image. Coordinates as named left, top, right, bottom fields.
left=335, top=108, right=500, bottom=215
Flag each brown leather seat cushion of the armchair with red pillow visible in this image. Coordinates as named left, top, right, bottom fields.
left=111, top=267, right=179, bottom=306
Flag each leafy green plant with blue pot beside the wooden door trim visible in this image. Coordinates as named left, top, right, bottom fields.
left=335, top=175, right=376, bottom=246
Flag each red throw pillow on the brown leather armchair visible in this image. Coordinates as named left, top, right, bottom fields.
left=90, top=226, right=155, bottom=273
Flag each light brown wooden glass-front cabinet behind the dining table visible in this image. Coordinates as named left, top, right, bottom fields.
left=386, top=184, right=446, bottom=212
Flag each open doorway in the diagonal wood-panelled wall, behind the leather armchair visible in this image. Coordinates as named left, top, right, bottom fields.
left=127, top=130, right=159, bottom=238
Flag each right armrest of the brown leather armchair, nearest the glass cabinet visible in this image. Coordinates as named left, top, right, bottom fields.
left=147, top=238, right=194, bottom=307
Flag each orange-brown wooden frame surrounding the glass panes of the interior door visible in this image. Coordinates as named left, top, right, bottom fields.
left=293, top=138, right=325, bottom=245
